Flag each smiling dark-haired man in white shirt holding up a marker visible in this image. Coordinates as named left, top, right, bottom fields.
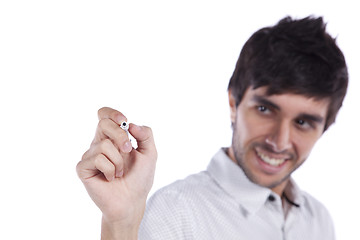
left=77, top=17, right=348, bottom=240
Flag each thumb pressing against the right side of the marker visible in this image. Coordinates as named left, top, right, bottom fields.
left=129, top=123, right=156, bottom=154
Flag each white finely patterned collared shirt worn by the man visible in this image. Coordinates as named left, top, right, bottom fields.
left=139, top=149, right=335, bottom=240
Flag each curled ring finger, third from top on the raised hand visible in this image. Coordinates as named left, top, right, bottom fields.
left=93, top=139, right=124, bottom=177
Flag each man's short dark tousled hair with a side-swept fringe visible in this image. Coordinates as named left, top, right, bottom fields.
left=228, top=16, right=348, bottom=131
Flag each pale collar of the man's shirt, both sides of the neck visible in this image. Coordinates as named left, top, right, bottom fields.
left=207, top=148, right=302, bottom=214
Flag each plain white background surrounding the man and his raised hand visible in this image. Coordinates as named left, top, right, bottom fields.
left=0, top=0, right=360, bottom=239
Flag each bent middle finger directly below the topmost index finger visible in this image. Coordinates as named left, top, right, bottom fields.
left=94, top=118, right=132, bottom=153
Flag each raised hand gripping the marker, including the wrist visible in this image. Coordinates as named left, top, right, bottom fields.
left=77, top=108, right=157, bottom=238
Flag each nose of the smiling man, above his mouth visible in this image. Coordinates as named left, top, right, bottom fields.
left=265, top=122, right=292, bottom=153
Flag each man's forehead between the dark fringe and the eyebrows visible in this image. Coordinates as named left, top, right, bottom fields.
left=240, top=87, right=330, bottom=117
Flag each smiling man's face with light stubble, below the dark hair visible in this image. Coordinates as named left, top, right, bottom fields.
left=229, top=87, right=329, bottom=194
